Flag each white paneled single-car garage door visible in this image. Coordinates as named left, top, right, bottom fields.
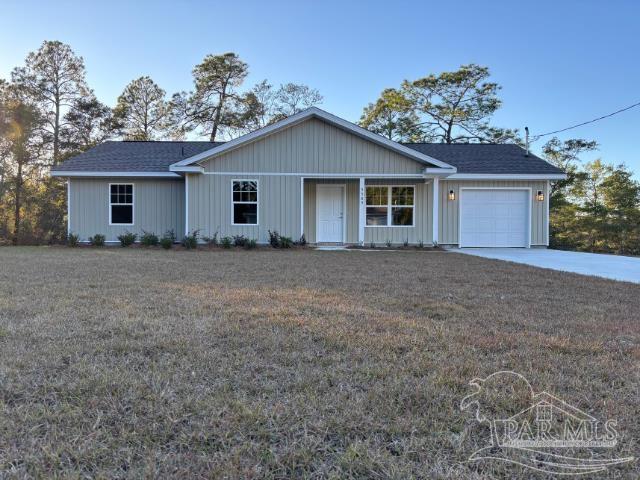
left=460, top=189, right=530, bottom=247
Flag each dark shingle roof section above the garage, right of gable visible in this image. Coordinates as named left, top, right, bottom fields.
left=403, top=143, right=563, bottom=174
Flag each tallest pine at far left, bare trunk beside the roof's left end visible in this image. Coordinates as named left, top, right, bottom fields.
left=11, top=41, right=88, bottom=164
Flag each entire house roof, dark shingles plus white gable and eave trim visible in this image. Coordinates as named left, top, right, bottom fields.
left=51, top=107, right=564, bottom=179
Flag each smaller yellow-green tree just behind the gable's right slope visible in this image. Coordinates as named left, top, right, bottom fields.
left=359, top=88, right=423, bottom=142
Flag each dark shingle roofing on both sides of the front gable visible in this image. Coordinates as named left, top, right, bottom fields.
left=54, top=141, right=562, bottom=174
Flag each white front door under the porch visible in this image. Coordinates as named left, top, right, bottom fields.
left=316, top=185, right=344, bottom=243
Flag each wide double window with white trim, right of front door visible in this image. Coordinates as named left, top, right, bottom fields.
left=366, top=185, right=415, bottom=227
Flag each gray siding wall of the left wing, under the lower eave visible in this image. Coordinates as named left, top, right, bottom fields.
left=69, top=178, right=185, bottom=241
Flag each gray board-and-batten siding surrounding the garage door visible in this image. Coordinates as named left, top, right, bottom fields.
left=438, top=180, right=549, bottom=246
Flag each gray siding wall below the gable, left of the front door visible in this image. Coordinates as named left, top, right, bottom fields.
left=187, top=174, right=300, bottom=243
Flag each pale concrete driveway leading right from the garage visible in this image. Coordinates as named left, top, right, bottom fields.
left=450, top=248, right=640, bottom=283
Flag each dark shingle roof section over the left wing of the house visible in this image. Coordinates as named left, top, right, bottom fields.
left=54, top=142, right=222, bottom=172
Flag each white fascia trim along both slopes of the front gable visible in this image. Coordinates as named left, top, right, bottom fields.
left=170, top=107, right=454, bottom=171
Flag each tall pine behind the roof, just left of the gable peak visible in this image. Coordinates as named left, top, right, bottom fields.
left=172, top=53, right=249, bottom=141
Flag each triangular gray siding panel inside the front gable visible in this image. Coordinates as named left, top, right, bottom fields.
left=201, top=119, right=426, bottom=174
